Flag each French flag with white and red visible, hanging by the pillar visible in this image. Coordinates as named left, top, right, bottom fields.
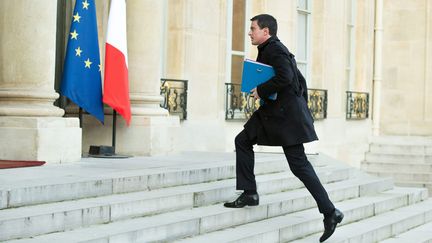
left=103, top=0, right=131, bottom=125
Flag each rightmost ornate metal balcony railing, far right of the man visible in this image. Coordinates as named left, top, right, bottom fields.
left=346, top=91, right=369, bottom=120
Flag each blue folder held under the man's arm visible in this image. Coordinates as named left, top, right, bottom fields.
left=241, top=59, right=277, bottom=100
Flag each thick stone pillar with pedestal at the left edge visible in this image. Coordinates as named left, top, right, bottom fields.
left=0, top=0, right=81, bottom=163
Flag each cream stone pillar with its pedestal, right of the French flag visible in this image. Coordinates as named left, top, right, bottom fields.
left=83, top=0, right=179, bottom=155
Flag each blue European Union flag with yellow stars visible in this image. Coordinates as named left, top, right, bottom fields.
left=60, top=0, right=104, bottom=123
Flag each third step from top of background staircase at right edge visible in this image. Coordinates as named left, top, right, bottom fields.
left=365, top=152, right=432, bottom=164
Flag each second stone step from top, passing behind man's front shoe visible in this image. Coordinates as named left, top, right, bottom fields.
left=0, top=166, right=352, bottom=240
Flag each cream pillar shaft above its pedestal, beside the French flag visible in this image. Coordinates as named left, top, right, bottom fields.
left=127, top=0, right=168, bottom=116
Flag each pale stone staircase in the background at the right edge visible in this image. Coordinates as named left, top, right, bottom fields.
left=362, top=137, right=432, bottom=195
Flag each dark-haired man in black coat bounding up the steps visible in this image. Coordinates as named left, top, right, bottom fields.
left=224, top=14, right=343, bottom=242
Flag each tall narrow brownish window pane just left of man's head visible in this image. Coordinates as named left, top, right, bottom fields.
left=231, top=0, right=246, bottom=51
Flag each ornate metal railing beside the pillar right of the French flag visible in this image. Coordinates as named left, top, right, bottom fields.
left=160, top=78, right=188, bottom=120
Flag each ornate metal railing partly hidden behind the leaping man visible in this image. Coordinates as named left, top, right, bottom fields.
left=225, top=83, right=327, bottom=120
